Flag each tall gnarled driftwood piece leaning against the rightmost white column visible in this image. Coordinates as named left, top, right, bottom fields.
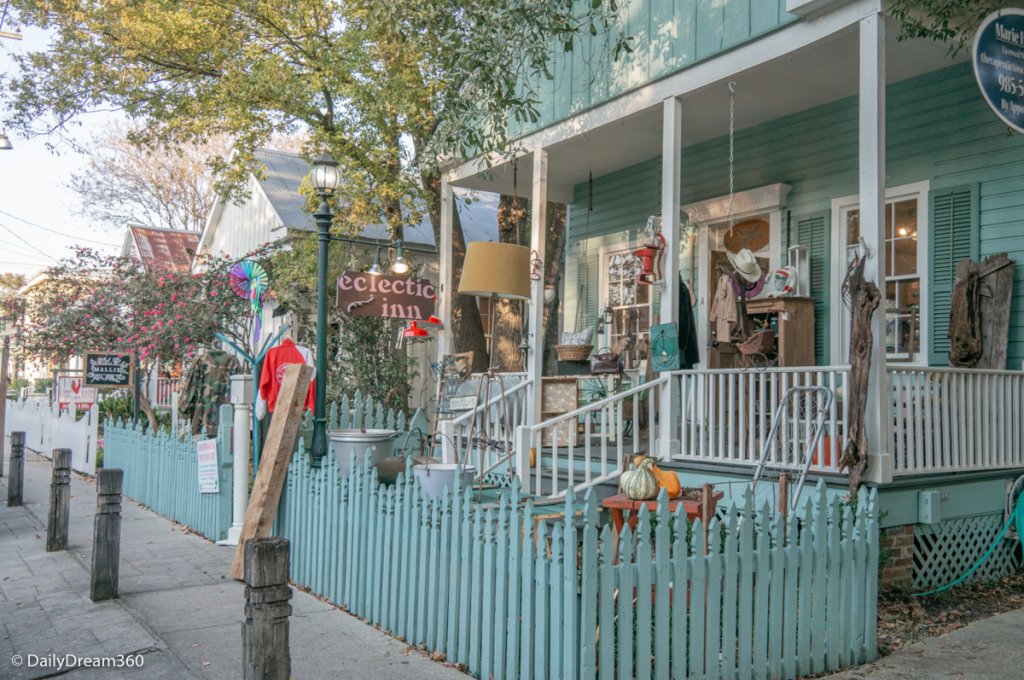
left=840, top=282, right=880, bottom=495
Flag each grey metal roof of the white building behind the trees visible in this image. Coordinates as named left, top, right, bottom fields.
left=254, top=148, right=498, bottom=246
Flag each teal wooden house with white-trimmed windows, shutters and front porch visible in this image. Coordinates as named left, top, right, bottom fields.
left=438, top=0, right=1024, bottom=587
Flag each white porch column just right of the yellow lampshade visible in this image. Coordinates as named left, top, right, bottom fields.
left=526, top=148, right=548, bottom=425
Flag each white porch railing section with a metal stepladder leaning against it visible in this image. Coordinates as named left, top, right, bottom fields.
left=672, top=366, right=850, bottom=473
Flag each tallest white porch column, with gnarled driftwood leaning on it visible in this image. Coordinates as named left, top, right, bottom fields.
left=860, top=8, right=893, bottom=482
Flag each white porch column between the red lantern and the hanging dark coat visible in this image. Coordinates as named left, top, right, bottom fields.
left=653, top=96, right=683, bottom=459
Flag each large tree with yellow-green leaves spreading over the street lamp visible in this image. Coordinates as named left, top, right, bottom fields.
left=0, top=0, right=629, bottom=383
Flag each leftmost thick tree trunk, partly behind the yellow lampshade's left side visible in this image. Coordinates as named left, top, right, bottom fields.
left=423, top=174, right=487, bottom=373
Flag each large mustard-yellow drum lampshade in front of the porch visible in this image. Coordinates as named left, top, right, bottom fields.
left=459, top=241, right=530, bottom=300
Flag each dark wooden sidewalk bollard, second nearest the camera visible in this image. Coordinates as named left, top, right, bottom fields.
left=89, top=468, right=124, bottom=602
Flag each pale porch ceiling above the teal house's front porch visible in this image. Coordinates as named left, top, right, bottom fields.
left=457, top=19, right=966, bottom=203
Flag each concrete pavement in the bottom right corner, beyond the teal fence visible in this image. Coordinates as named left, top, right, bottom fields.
left=828, top=609, right=1024, bottom=680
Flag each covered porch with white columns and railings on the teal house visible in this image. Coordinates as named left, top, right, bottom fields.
left=438, top=3, right=1024, bottom=503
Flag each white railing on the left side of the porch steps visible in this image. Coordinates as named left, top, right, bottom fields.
left=438, top=374, right=534, bottom=476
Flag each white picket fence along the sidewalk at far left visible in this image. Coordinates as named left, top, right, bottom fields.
left=4, top=398, right=99, bottom=475
